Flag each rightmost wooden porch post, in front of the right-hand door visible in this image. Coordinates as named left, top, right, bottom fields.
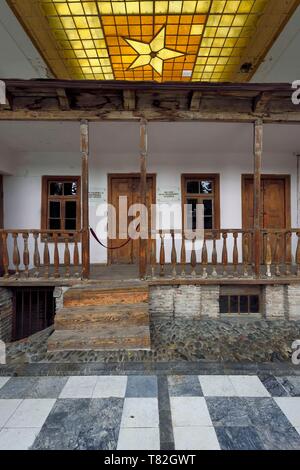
left=253, top=119, right=263, bottom=277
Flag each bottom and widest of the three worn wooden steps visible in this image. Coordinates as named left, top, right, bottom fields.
left=48, top=325, right=150, bottom=352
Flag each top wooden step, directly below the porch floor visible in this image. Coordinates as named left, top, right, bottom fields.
left=64, top=287, right=148, bottom=307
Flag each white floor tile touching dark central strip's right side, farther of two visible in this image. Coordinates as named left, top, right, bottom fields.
left=170, top=397, right=212, bottom=427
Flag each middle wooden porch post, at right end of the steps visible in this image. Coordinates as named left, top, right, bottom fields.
left=139, top=119, right=149, bottom=278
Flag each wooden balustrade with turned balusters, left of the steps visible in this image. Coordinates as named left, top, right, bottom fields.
left=0, top=229, right=81, bottom=279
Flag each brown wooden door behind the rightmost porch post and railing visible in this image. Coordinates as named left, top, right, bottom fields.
left=242, top=175, right=291, bottom=262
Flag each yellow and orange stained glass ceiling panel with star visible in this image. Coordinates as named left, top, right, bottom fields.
left=21, top=0, right=268, bottom=82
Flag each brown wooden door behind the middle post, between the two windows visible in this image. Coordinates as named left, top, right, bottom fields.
left=108, top=175, right=155, bottom=264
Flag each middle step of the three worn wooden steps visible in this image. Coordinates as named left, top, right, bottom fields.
left=54, top=303, right=149, bottom=330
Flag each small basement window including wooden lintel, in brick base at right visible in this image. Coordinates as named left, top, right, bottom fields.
left=219, top=286, right=261, bottom=315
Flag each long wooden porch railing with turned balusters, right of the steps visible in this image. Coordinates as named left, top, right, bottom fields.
left=150, top=229, right=300, bottom=279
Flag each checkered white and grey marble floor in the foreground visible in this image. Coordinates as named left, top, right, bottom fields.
left=0, top=374, right=300, bottom=450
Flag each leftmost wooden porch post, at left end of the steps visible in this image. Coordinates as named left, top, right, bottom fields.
left=80, top=120, right=90, bottom=279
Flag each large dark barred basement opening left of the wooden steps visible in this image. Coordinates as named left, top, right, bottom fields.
left=13, top=287, right=55, bottom=341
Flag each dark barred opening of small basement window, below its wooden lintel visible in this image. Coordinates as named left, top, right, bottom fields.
left=219, top=294, right=260, bottom=315
